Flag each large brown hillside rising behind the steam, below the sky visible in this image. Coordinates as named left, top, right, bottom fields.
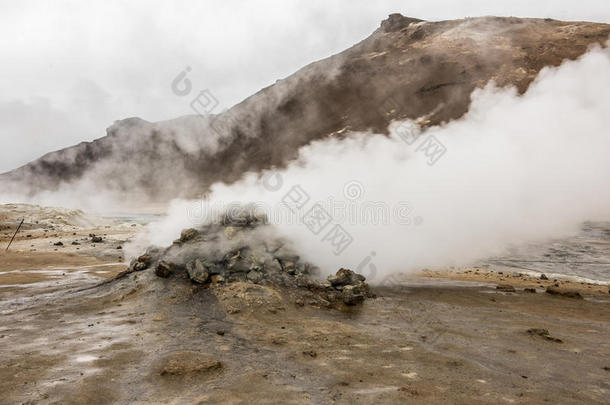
left=0, top=14, right=610, bottom=202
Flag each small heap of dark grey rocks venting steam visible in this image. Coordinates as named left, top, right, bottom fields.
left=129, top=209, right=372, bottom=306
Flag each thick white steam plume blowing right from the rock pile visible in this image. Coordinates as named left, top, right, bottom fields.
left=128, top=47, right=610, bottom=282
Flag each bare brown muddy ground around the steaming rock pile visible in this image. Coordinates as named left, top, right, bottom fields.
left=0, top=207, right=610, bottom=404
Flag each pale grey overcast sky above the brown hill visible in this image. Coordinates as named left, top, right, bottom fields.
left=0, top=0, right=610, bottom=172
